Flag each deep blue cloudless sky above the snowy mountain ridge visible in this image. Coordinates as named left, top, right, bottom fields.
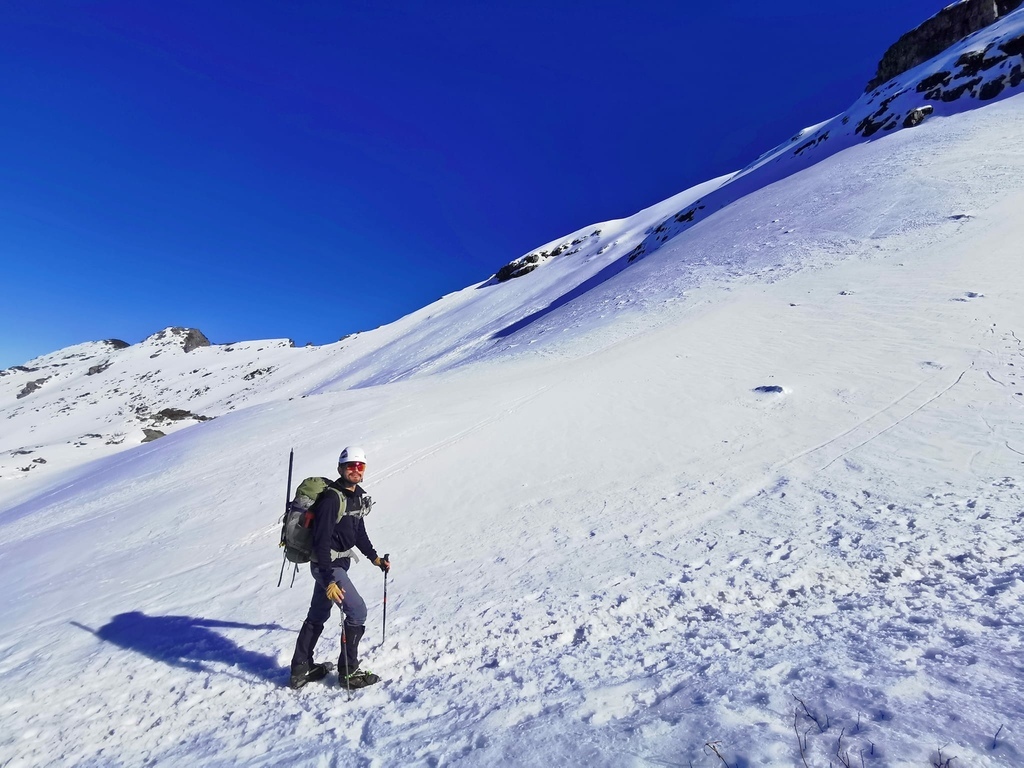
left=0, top=0, right=947, bottom=368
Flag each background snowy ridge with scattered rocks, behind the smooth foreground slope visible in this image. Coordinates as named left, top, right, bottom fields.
left=8, top=11, right=1024, bottom=499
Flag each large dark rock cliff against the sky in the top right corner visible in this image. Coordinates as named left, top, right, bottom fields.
left=864, top=0, right=1024, bottom=92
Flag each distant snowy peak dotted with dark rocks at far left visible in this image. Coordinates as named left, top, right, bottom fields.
left=0, top=327, right=305, bottom=482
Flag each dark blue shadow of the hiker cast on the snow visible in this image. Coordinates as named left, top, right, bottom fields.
left=72, top=610, right=287, bottom=683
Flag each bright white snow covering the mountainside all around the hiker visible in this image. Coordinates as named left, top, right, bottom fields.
left=0, top=14, right=1024, bottom=767
